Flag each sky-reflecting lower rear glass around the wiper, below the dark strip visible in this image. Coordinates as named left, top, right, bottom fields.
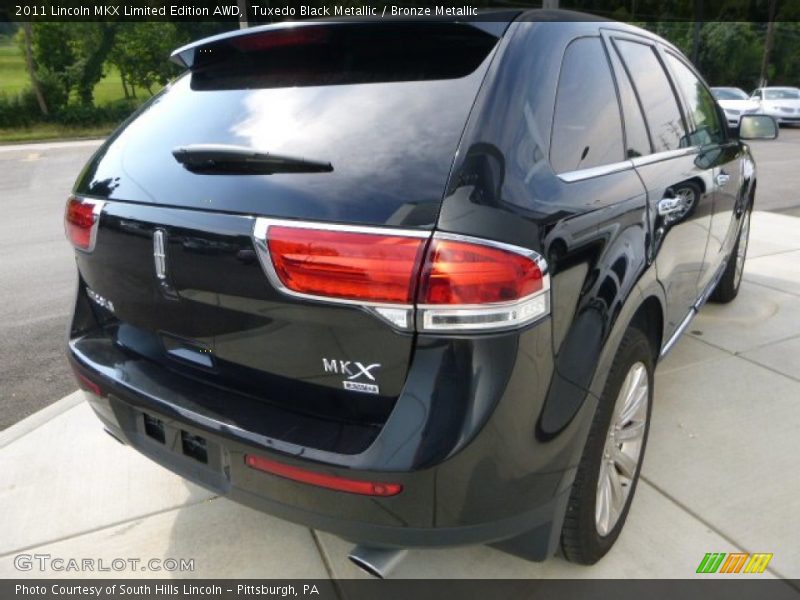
left=78, top=36, right=491, bottom=227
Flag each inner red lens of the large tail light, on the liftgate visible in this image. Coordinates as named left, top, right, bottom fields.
left=267, top=225, right=425, bottom=304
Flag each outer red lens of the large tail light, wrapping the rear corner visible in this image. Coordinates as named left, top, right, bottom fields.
left=418, top=238, right=544, bottom=304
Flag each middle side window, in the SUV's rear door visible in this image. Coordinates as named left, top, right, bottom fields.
left=614, top=40, right=686, bottom=152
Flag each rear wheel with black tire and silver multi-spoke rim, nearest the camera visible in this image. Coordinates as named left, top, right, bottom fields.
left=561, top=327, right=654, bottom=565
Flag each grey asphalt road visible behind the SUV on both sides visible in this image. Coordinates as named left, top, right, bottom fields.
left=0, top=129, right=800, bottom=430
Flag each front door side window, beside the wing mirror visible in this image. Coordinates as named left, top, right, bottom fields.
left=666, top=52, right=725, bottom=146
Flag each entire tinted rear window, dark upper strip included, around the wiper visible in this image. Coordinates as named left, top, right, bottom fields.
left=78, top=24, right=496, bottom=228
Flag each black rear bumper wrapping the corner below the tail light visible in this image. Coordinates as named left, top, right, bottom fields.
left=68, top=314, right=595, bottom=560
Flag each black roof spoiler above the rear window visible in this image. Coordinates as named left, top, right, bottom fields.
left=170, top=10, right=522, bottom=69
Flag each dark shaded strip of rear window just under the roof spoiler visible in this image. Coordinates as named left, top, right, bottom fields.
left=192, top=23, right=497, bottom=90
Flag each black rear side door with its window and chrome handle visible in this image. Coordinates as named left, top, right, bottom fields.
left=609, top=32, right=714, bottom=337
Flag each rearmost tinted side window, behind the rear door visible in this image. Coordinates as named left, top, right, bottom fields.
left=550, top=37, right=624, bottom=173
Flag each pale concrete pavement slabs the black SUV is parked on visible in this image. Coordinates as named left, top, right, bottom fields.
left=0, top=212, right=800, bottom=579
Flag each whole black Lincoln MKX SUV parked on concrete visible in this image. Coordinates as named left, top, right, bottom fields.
left=66, top=11, right=777, bottom=575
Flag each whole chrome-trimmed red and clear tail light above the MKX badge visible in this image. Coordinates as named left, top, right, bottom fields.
left=253, top=219, right=549, bottom=331
